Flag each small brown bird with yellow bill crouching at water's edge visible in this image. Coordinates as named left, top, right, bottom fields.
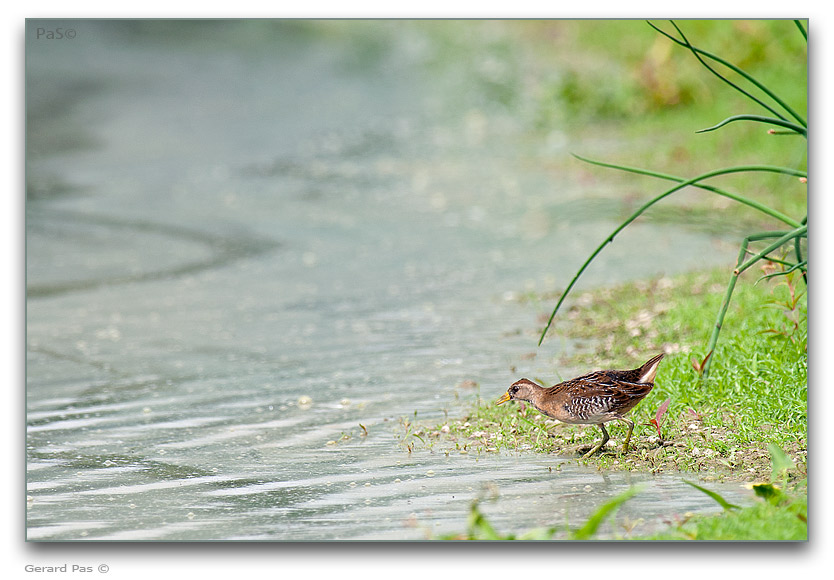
left=495, top=353, right=663, bottom=459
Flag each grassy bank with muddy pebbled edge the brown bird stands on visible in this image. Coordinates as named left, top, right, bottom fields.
left=406, top=270, right=807, bottom=481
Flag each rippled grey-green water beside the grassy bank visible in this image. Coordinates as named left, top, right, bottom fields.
left=26, top=21, right=749, bottom=540
